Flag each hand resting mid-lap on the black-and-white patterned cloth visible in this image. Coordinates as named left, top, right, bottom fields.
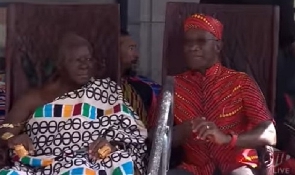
left=88, top=137, right=116, bottom=160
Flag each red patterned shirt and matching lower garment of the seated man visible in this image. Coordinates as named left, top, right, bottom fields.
left=174, top=64, right=273, bottom=175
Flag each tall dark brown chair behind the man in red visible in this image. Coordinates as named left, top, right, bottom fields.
left=163, top=2, right=279, bottom=174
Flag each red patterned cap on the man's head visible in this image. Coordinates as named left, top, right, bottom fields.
left=184, top=14, right=223, bottom=40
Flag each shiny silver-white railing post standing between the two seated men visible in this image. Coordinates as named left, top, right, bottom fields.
left=148, top=76, right=174, bottom=175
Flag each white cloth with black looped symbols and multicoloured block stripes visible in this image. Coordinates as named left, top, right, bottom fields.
left=0, top=79, right=147, bottom=175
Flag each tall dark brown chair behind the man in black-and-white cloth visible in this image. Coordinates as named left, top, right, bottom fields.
left=0, top=4, right=120, bottom=166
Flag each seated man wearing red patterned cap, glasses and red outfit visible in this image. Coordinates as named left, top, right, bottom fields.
left=168, top=14, right=276, bottom=175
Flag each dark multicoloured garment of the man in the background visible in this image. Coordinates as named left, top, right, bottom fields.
left=122, top=76, right=161, bottom=125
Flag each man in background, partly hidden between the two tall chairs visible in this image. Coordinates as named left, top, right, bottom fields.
left=120, top=30, right=161, bottom=125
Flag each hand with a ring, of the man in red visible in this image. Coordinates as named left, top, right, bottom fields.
left=192, top=118, right=231, bottom=145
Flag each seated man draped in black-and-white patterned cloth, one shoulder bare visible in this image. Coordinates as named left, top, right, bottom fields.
left=0, top=34, right=147, bottom=175
